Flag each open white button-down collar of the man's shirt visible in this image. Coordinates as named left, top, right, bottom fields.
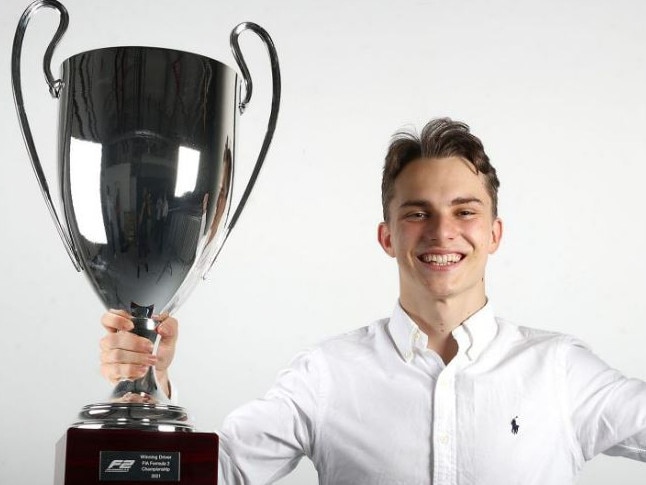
left=388, top=302, right=498, bottom=362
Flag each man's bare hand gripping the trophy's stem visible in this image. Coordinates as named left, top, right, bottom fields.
left=101, top=310, right=177, bottom=396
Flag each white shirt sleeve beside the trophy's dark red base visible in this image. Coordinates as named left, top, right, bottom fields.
left=218, top=350, right=322, bottom=485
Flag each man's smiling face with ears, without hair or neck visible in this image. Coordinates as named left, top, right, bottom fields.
left=379, top=157, right=502, bottom=306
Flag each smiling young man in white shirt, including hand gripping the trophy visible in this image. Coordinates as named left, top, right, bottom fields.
left=102, top=119, right=646, bottom=485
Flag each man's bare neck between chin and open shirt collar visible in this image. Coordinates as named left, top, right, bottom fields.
left=400, top=293, right=487, bottom=364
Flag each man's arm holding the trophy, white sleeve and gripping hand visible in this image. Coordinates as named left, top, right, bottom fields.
left=101, top=312, right=327, bottom=485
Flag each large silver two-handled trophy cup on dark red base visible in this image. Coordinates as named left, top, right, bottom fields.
left=12, top=0, right=280, bottom=485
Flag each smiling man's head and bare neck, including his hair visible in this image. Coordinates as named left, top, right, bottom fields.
left=379, top=129, right=502, bottom=363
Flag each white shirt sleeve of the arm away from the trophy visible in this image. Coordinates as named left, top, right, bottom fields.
left=564, top=338, right=646, bottom=461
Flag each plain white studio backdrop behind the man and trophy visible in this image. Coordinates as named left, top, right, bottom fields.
left=0, top=0, right=646, bottom=485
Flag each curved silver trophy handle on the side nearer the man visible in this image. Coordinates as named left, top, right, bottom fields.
left=202, top=22, right=281, bottom=278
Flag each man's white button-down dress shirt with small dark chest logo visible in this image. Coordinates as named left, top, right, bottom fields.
left=220, top=304, right=646, bottom=485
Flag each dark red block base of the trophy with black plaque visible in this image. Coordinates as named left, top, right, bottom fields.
left=54, top=428, right=218, bottom=485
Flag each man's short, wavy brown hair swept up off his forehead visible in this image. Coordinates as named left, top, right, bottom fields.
left=381, top=118, right=500, bottom=222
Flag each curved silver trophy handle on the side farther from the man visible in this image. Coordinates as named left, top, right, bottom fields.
left=11, top=0, right=81, bottom=271
